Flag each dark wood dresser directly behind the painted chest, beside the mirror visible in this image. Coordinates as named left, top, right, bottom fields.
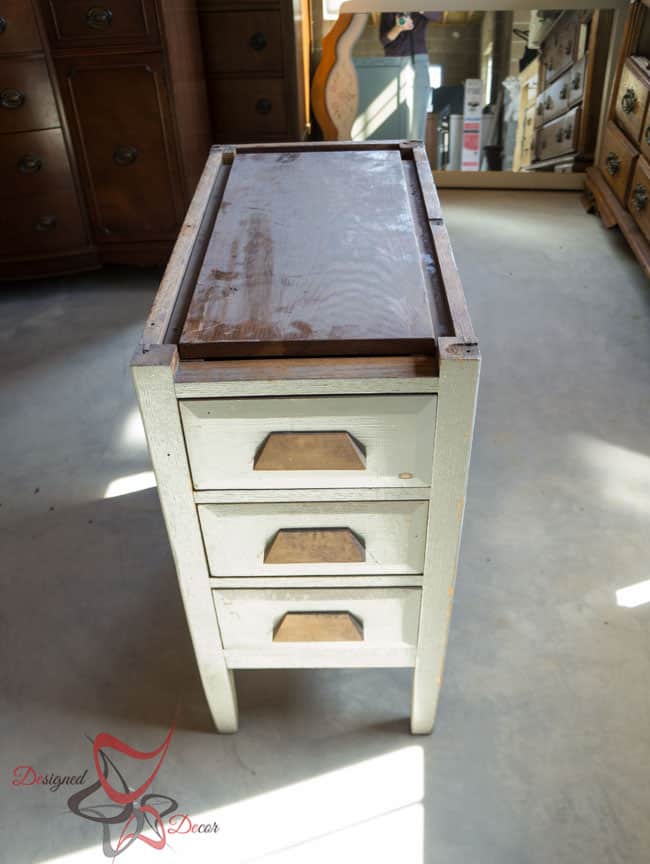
left=198, top=0, right=310, bottom=144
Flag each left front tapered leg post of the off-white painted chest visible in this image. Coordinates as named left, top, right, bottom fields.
left=131, top=345, right=238, bottom=732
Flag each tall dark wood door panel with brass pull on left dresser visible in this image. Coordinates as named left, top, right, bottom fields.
left=57, top=51, right=182, bottom=243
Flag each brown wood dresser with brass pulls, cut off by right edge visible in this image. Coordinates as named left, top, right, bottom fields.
left=585, top=2, right=650, bottom=276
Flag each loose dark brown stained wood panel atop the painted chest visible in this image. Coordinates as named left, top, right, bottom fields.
left=179, top=150, right=435, bottom=359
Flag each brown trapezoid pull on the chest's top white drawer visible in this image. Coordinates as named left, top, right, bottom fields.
left=253, top=432, right=366, bottom=471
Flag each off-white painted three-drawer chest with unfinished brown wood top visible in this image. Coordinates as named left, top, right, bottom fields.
left=132, top=142, right=480, bottom=733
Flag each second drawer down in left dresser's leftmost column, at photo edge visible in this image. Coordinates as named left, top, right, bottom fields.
left=0, top=57, right=59, bottom=132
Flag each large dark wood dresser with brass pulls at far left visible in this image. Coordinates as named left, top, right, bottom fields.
left=0, top=0, right=210, bottom=279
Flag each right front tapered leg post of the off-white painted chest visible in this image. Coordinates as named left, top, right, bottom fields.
left=411, top=339, right=480, bottom=735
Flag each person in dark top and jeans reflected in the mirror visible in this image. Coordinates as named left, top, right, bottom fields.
left=379, top=12, right=443, bottom=141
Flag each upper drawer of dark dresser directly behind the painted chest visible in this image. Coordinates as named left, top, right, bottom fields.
left=201, top=10, right=283, bottom=75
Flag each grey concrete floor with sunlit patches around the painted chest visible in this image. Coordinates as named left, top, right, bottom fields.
left=0, top=191, right=650, bottom=864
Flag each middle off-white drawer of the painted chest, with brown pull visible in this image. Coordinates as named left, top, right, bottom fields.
left=198, top=501, right=429, bottom=576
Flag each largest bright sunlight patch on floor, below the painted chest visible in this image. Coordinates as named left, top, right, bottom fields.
left=41, top=745, right=424, bottom=864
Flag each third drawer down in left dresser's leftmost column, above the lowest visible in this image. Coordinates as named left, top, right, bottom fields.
left=0, top=129, right=74, bottom=198
